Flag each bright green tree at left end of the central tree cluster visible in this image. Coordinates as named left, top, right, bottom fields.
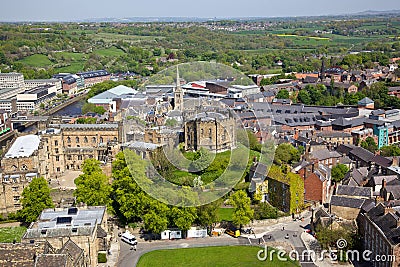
left=74, top=159, right=111, bottom=206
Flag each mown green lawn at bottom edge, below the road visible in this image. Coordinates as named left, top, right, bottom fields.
left=137, top=246, right=299, bottom=267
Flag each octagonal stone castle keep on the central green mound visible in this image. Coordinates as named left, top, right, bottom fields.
left=185, top=112, right=236, bottom=152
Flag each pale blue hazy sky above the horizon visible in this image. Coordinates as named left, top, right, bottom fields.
left=0, top=0, right=400, bottom=21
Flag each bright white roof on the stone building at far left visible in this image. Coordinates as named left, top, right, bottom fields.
left=5, top=134, right=40, bottom=158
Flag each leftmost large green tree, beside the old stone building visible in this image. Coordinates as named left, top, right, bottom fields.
left=18, top=178, right=54, bottom=223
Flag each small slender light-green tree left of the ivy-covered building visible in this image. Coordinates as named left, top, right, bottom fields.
left=229, top=190, right=254, bottom=229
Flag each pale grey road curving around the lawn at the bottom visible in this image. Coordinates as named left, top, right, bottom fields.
left=116, top=214, right=315, bottom=267
